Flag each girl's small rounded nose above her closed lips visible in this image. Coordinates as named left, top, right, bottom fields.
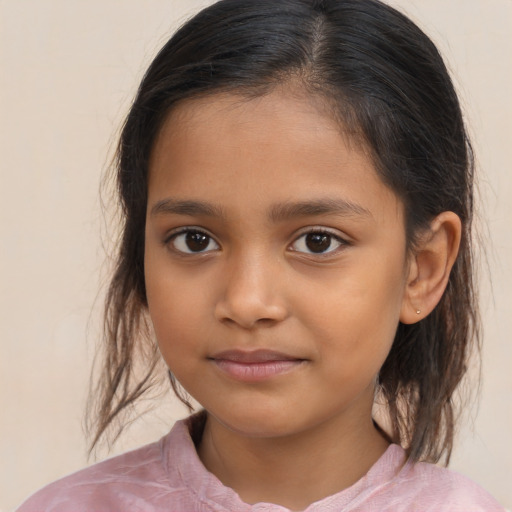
left=215, top=251, right=288, bottom=329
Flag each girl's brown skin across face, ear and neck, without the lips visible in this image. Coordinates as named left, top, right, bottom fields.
left=145, top=85, right=460, bottom=510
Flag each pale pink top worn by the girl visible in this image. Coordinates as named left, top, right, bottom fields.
left=18, top=420, right=504, bottom=512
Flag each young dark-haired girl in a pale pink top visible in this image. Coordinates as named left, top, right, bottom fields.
left=19, top=0, right=502, bottom=512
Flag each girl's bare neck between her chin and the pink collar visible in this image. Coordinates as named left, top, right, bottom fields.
left=198, top=404, right=388, bottom=510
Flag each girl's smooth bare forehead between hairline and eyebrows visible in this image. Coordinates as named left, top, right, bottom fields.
left=149, top=89, right=402, bottom=223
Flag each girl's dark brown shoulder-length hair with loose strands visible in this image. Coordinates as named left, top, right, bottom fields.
left=86, top=0, right=479, bottom=461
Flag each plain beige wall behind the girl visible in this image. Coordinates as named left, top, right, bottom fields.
left=0, top=0, right=512, bottom=511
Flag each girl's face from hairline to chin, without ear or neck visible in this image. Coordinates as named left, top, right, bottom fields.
left=145, top=90, right=407, bottom=436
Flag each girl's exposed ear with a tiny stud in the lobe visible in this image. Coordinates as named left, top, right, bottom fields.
left=400, top=212, right=462, bottom=324
